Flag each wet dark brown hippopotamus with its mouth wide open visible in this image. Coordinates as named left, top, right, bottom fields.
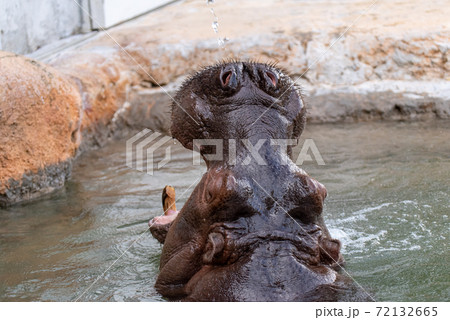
left=150, top=61, right=366, bottom=301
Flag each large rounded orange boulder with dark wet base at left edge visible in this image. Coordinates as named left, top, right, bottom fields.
left=0, top=52, right=81, bottom=204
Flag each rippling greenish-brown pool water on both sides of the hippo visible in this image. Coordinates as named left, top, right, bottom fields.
left=0, top=122, right=450, bottom=301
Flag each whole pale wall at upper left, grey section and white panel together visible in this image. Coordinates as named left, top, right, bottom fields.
left=0, top=0, right=179, bottom=54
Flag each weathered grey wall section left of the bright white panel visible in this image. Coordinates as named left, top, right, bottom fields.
left=0, top=0, right=82, bottom=54
